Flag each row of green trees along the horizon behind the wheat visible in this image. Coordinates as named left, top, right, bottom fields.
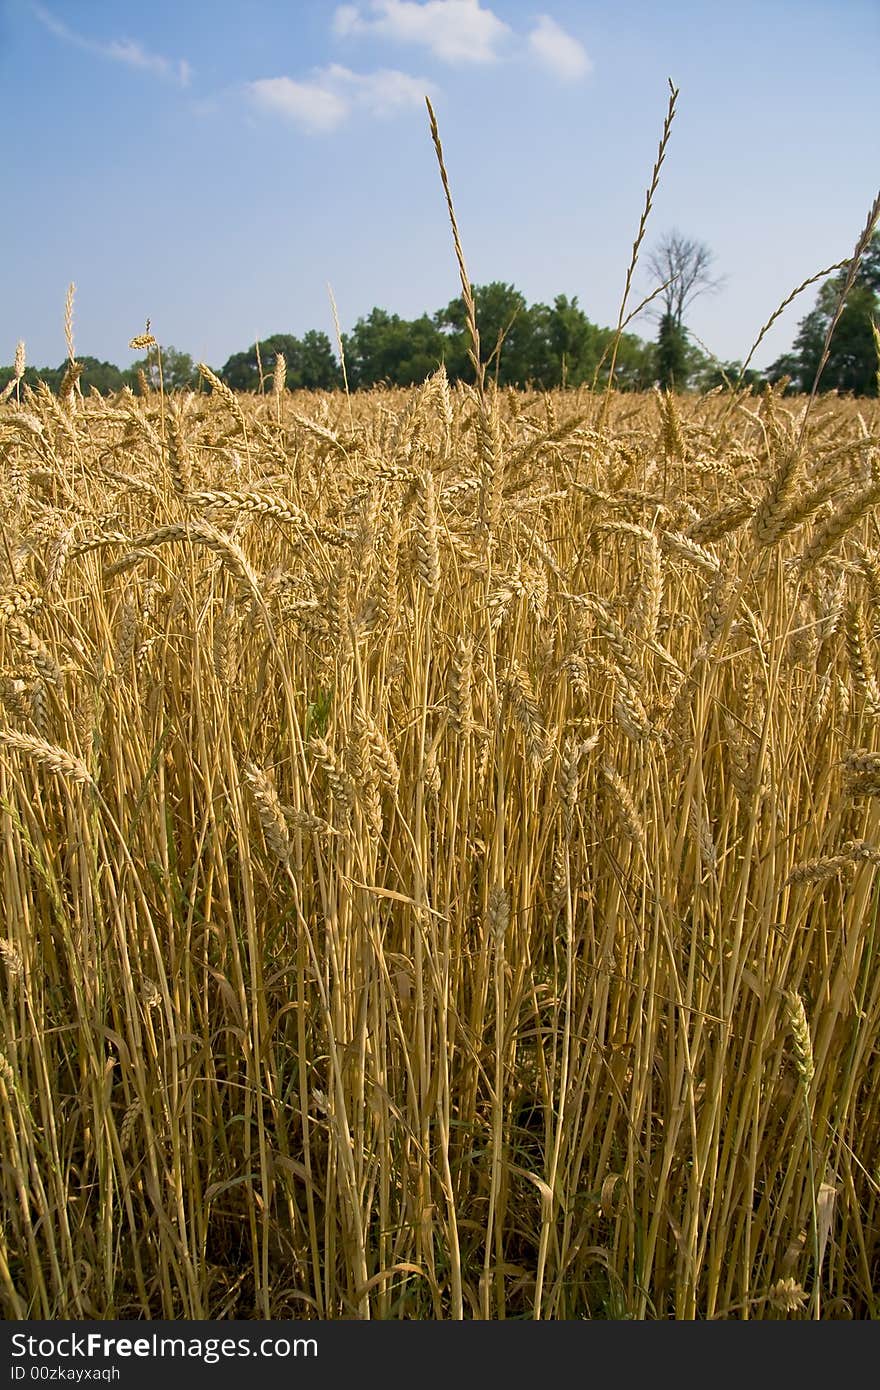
left=0, top=232, right=880, bottom=396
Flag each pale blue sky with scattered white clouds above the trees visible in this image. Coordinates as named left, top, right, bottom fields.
left=0, top=0, right=880, bottom=367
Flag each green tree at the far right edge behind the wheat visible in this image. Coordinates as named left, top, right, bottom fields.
left=767, top=234, right=880, bottom=396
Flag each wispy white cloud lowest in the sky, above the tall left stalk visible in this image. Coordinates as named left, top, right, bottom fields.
left=245, top=63, right=434, bottom=135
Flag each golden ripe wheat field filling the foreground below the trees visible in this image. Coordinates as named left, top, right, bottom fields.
left=0, top=353, right=880, bottom=1319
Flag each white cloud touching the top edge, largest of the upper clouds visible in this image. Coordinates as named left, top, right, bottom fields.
left=334, top=0, right=510, bottom=63
